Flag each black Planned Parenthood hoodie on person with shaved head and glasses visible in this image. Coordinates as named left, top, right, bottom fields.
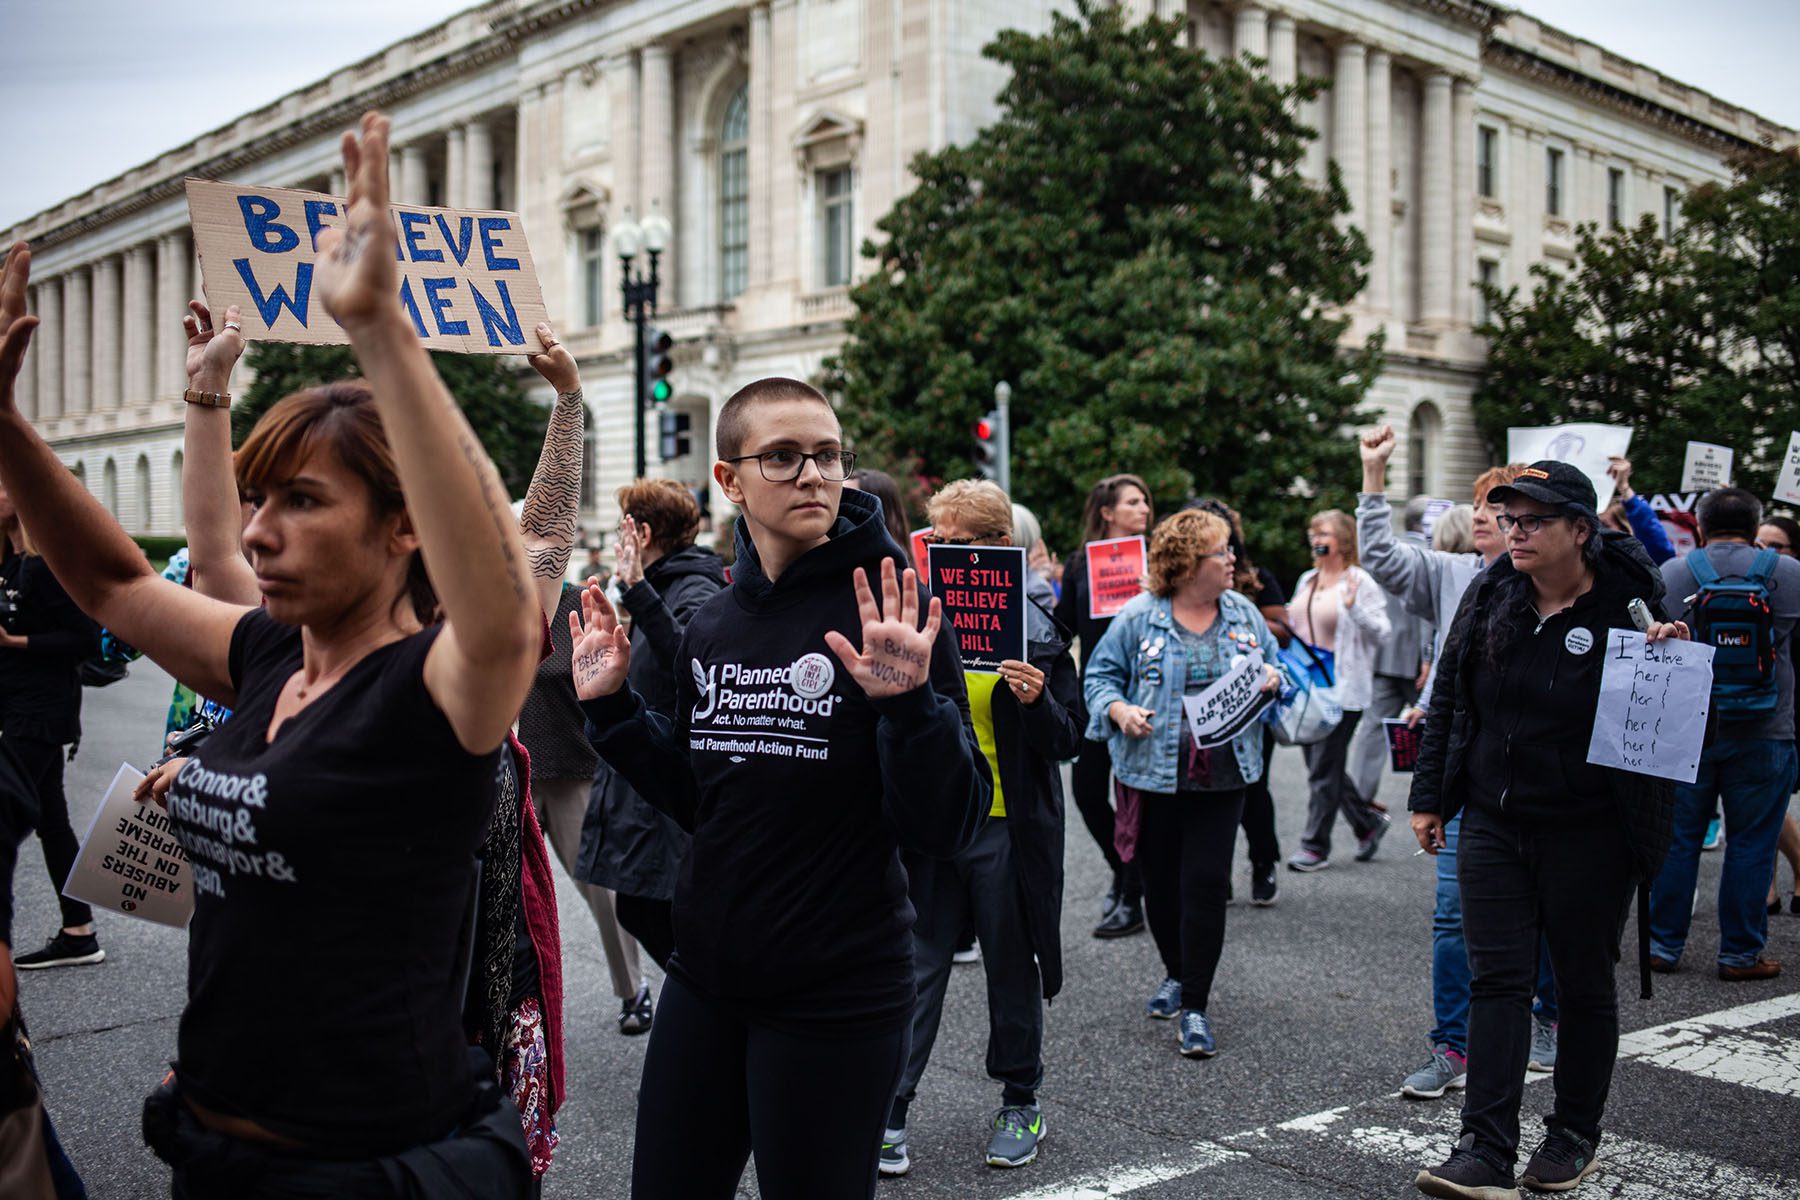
left=583, top=489, right=992, bottom=1034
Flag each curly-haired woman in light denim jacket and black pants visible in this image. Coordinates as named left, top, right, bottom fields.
left=1085, top=509, right=1280, bottom=1058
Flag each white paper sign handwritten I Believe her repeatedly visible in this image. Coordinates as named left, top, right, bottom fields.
left=1588, top=630, right=1712, bottom=783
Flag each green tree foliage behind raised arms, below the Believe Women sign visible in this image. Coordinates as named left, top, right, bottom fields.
left=232, top=342, right=549, bottom=497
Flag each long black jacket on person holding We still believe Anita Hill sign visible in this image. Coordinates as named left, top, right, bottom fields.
left=905, top=603, right=1087, bottom=1000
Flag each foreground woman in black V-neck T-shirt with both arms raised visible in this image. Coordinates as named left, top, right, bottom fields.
left=0, top=113, right=542, bottom=1200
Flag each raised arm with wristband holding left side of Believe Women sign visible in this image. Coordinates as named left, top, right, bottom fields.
left=182, top=300, right=263, bottom=604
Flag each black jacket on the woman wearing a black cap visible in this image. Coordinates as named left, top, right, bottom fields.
left=1408, top=531, right=1674, bottom=997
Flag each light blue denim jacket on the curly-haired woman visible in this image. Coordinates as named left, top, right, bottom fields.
left=1085, top=592, right=1276, bottom=792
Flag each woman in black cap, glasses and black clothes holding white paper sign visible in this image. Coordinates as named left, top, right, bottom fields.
left=1408, top=461, right=1688, bottom=1198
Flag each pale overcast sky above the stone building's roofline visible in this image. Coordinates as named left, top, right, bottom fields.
left=0, top=0, right=1800, bottom=227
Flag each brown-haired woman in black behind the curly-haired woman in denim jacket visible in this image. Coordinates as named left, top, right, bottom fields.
left=1055, top=475, right=1154, bottom=937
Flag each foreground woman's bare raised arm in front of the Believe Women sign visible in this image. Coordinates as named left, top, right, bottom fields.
left=313, top=113, right=544, bottom=754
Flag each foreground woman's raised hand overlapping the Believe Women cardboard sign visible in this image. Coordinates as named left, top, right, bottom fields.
left=313, top=112, right=400, bottom=333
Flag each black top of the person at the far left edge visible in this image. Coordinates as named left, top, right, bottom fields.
left=0, top=554, right=101, bottom=745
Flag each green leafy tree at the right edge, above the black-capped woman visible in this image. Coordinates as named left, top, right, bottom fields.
left=1474, top=151, right=1800, bottom=497
